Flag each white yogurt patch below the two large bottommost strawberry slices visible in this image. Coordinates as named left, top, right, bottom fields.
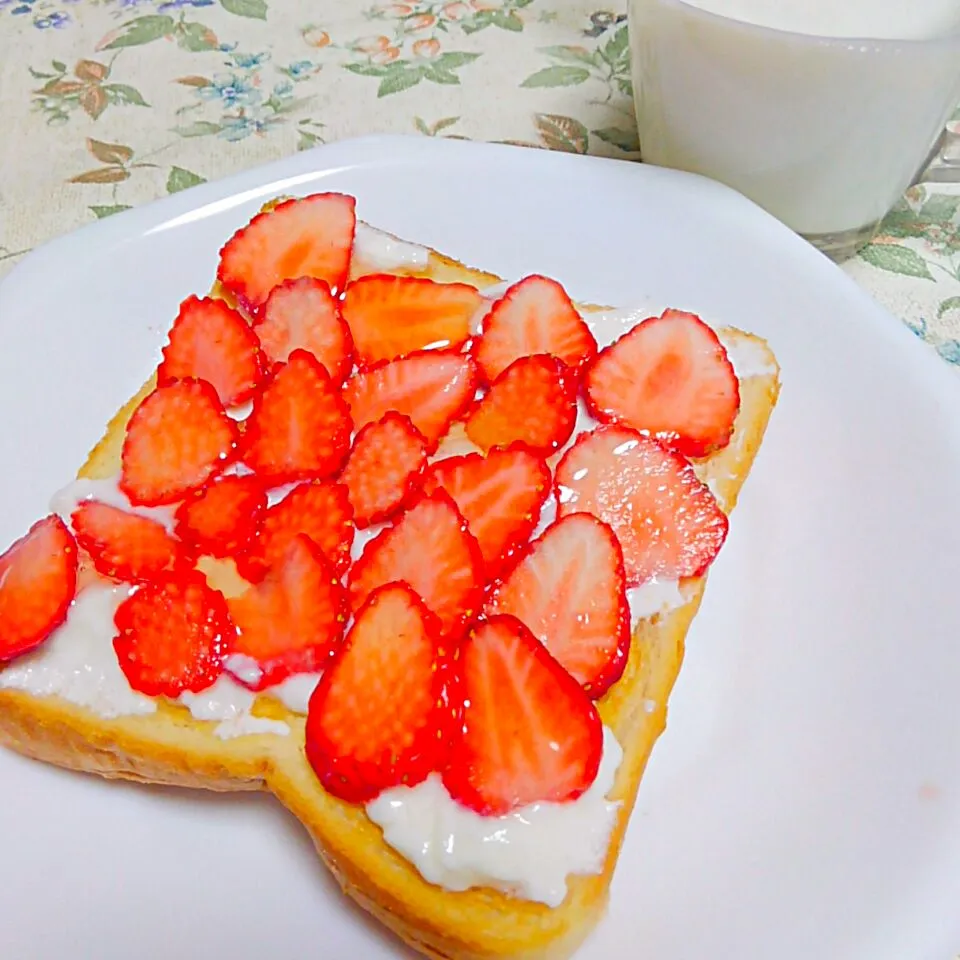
left=366, top=727, right=623, bottom=907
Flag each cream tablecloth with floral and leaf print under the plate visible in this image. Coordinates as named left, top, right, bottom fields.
left=0, top=0, right=960, bottom=368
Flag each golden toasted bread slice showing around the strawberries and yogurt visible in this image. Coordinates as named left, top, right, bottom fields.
left=0, top=223, right=779, bottom=960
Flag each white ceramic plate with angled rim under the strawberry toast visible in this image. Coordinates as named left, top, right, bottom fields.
left=0, top=138, right=960, bottom=960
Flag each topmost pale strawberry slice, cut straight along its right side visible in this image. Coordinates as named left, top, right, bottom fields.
left=217, top=193, right=357, bottom=314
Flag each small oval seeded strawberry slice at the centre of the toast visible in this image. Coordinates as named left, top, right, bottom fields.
left=340, top=413, right=427, bottom=530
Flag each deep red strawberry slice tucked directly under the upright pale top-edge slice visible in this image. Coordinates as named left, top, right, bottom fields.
left=464, top=354, right=577, bottom=456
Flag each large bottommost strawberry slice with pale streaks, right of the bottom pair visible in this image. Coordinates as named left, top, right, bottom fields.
left=443, top=616, right=603, bottom=817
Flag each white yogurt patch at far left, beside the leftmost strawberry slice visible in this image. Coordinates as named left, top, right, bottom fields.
left=0, top=584, right=157, bottom=720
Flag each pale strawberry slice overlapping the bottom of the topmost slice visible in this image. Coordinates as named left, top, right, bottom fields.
left=256, top=277, right=353, bottom=386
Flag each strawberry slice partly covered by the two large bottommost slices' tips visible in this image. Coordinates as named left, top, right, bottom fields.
left=348, top=490, right=483, bottom=635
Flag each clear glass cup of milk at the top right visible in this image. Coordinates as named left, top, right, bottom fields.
left=629, top=0, right=960, bottom=260
